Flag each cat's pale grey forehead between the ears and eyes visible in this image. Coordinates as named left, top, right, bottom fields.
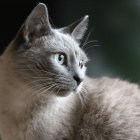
left=41, top=29, right=87, bottom=59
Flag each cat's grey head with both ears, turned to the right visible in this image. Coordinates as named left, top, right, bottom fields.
left=4, top=3, right=88, bottom=95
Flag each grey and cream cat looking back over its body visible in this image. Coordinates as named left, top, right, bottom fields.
left=0, top=3, right=140, bottom=140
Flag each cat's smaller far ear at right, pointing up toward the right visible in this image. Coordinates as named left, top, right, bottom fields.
left=61, top=15, right=89, bottom=43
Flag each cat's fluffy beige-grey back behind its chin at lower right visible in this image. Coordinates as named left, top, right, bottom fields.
left=78, top=77, right=140, bottom=140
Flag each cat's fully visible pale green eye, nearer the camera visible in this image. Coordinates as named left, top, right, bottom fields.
left=54, top=53, right=66, bottom=65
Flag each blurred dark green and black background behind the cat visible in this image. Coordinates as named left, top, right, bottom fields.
left=0, top=0, right=140, bottom=83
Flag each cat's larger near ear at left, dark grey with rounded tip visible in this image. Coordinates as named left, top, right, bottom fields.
left=24, top=3, right=51, bottom=42
